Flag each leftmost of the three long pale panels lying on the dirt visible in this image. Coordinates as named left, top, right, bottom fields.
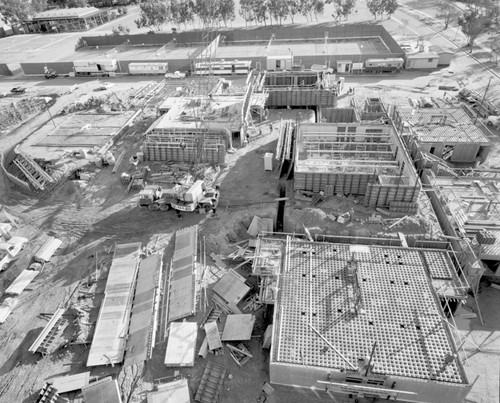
left=87, top=242, right=141, bottom=367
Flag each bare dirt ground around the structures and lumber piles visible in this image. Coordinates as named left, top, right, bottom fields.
left=0, top=34, right=500, bottom=403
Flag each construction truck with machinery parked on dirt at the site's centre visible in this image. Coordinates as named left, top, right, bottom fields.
left=138, top=180, right=219, bottom=212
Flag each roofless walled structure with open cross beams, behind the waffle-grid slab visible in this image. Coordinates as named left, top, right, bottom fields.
left=294, top=122, right=420, bottom=208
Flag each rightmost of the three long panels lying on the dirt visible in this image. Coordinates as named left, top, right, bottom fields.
left=167, top=225, right=198, bottom=322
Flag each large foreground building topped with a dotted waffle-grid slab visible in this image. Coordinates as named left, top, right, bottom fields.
left=270, top=241, right=470, bottom=403
